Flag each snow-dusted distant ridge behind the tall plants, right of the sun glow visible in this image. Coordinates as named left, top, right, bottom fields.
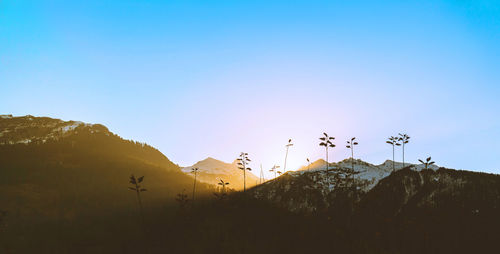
left=251, top=159, right=439, bottom=212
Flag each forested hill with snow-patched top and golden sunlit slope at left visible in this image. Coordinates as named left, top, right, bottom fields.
left=0, top=116, right=208, bottom=253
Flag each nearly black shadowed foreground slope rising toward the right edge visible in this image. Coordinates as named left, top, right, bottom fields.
left=152, top=168, right=500, bottom=254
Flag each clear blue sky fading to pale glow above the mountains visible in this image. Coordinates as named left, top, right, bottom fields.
left=0, top=0, right=500, bottom=177
